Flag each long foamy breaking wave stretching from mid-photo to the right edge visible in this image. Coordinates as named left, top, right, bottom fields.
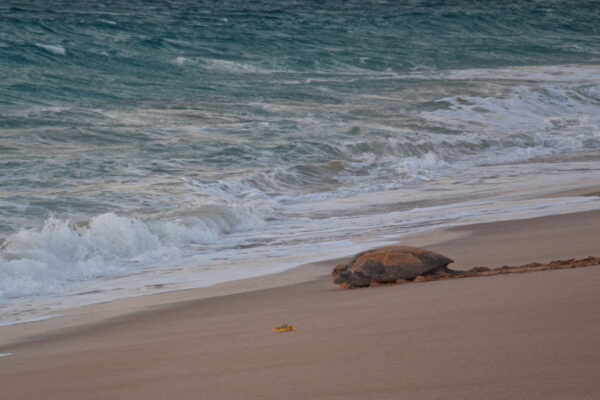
left=237, top=80, right=600, bottom=196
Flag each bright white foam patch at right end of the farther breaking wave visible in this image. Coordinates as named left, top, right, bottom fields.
left=421, top=85, right=600, bottom=164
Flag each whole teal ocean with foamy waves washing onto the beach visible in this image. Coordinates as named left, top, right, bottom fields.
left=0, top=0, right=600, bottom=324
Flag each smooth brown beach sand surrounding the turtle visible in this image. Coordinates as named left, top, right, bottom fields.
left=0, top=212, right=600, bottom=399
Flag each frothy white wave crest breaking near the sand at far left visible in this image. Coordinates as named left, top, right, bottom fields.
left=0, top=206, right=255, bottom=298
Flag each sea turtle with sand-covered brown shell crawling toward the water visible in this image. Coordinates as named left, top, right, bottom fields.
left=331, top=246, right=461, bottom=287
